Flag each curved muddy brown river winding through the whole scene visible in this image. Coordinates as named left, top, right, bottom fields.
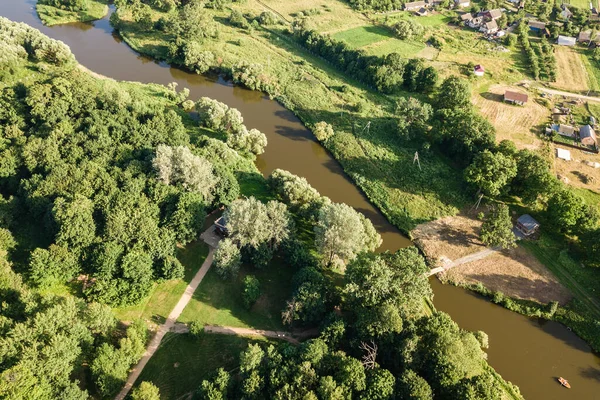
left=0, top=0, right=600, bottom=400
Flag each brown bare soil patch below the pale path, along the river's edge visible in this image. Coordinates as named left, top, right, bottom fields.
left=441, top=247, right=570, bottom=304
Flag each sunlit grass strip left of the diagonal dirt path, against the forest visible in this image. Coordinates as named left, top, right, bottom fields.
left=114, top=241, right=208, bottom=324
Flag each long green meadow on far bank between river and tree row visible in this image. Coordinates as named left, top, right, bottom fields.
left=115, top=5, right=465, bottom=231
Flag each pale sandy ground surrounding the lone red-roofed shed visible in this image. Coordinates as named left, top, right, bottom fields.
left=472, top=85, right=550, bottom=149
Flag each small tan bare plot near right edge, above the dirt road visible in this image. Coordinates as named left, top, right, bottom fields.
left=552, top=46, right=590, bottom=92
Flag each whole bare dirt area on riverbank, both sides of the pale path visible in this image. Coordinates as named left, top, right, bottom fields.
left=412, top=209, right=569, bottom=304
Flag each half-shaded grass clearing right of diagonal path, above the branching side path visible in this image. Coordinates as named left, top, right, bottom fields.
left=179, top=258, right=294, bottom=330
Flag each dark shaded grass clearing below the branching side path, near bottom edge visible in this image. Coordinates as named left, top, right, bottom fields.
left=136, top=333, right=265, bottom=399
